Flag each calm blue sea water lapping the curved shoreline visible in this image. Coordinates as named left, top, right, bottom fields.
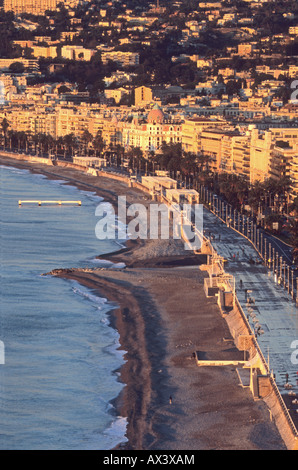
left=0, top=166, right=126, bottom=450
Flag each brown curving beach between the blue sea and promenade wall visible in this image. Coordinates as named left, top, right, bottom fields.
left=0, top=157, right=286, bottom=450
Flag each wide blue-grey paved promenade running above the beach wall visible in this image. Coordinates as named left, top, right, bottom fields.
left=204, top=209, right=298, bottom=392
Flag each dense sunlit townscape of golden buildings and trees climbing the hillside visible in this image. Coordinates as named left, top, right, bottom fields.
left=0, top=0, right=298, bottom=260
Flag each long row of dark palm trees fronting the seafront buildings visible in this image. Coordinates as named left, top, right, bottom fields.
left=0, top=118, right=298, bottom=215
